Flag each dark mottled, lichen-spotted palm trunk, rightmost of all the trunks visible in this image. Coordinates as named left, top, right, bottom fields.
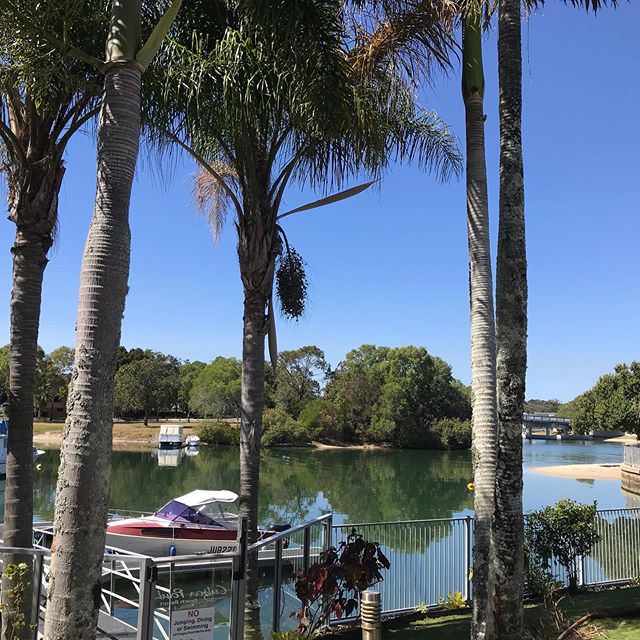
left=494, top=0, right=527, bottom=640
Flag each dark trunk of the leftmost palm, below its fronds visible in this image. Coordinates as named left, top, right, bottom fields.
left=2, top=154, right=64, bottom=637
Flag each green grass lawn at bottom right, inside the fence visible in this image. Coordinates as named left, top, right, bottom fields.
left=383, top=588, right=640, bottom=640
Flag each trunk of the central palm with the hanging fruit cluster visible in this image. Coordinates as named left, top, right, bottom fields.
left=238, top=208, right=276, bottom=638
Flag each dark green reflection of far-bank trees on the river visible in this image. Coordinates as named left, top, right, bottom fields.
left=27, top=447, right=473, bottom=544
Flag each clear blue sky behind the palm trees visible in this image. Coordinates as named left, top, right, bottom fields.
left=0, top=2, right=640, bottom=400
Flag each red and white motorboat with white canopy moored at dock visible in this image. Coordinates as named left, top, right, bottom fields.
left=106, top=489, right=289, bottom=558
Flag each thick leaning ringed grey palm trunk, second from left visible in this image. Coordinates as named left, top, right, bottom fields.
left=44, top=2, right=142, bottom=640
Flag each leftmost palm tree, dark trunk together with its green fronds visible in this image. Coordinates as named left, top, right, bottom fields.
left=0, top=0, right=106, bottom=576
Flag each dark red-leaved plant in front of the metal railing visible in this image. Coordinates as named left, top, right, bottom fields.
left=291, top=530, right=391, bottom=636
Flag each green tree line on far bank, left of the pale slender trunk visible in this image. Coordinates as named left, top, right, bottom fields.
left=18, top=345, right=471, bottom=449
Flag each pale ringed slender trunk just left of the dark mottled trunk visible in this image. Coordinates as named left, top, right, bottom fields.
left=462, top=14, right=497, bottom=640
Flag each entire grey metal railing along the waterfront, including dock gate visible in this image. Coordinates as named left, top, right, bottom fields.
left=5, top=509, right=640, bottom=640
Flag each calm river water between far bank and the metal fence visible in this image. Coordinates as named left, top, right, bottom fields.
left=18, top=440, right=640, bottom=523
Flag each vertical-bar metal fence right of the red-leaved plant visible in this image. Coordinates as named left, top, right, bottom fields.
left=334, top=509, right=640, bottom=615
